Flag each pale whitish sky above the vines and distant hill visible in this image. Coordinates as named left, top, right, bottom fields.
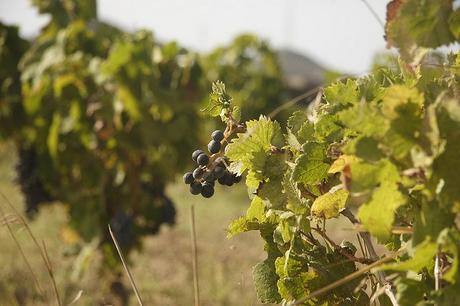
left=0, top=0, right=388, bottom=74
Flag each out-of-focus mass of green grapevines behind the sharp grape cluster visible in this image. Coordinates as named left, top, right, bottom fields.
left=0, top=0, right=304, bottom=266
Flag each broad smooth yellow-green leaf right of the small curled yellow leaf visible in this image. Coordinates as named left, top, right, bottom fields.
left=358, top=182, right=406, bottom=241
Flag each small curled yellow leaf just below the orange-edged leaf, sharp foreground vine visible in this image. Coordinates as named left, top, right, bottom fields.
left=311, top=189, right=348, bottom=219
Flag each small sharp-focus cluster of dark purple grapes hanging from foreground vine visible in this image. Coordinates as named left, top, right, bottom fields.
left=184, top=130, right=241, bottom=198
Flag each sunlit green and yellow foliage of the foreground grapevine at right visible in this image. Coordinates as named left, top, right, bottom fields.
left=198, top=0, right=460, bottom=305
